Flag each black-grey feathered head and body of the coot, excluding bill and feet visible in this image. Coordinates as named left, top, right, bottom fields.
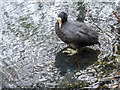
left=55, top=12, right=98, bottom=49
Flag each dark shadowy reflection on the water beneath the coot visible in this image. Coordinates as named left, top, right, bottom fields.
left=55, top=47, right=99, bottom=75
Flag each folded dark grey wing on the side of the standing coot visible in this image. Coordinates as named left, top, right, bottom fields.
left=63, top=22, right=98, bottom=44
